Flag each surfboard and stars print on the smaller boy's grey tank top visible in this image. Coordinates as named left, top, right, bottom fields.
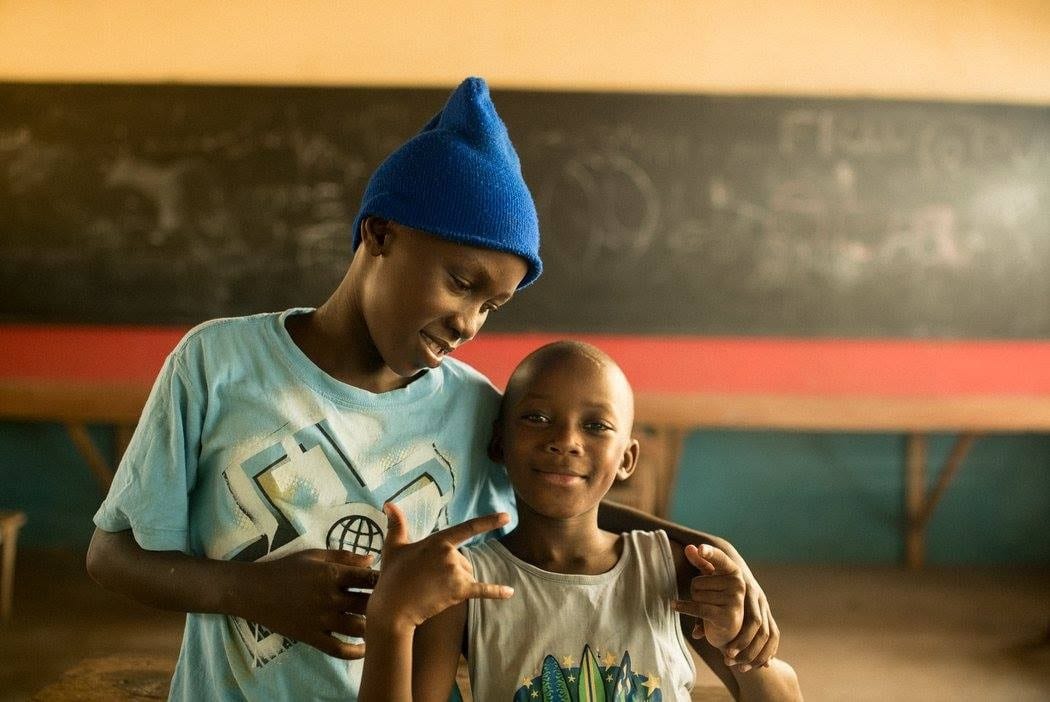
left=512, top=644, right=664, bottom=702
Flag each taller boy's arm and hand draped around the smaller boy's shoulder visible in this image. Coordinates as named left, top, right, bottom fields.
left=599, top=501, right=780, bottom=665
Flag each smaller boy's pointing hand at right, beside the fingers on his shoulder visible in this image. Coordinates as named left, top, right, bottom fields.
left=673, top=545, right=746, bottom=653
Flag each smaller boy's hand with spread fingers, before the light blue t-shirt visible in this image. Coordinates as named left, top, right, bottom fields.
left=369, top=503, right=513, bottom=629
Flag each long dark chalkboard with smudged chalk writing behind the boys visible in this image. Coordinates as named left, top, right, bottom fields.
left=0, top=83, right=1050, bottom=338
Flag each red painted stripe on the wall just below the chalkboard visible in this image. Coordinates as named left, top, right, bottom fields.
left=0, top=324, right=1050, bottom=397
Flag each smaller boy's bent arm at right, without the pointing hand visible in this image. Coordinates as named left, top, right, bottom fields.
left=671, top=544, right=802, bottom=701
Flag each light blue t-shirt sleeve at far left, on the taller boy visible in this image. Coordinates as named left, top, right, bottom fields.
left=95, top=347, right=204, bottom=553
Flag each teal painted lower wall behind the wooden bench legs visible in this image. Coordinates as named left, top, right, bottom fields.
left=0, top=423, right=1050, bottom=565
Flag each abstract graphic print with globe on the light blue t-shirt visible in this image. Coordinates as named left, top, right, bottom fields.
left=221, top=420, right=455, bottom=667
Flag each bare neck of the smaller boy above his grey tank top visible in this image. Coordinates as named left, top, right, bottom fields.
left=500, top=501, right=624, bottom=575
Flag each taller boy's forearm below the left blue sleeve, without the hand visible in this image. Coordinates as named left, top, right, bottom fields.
left=87, top=529, right=251, bottom=615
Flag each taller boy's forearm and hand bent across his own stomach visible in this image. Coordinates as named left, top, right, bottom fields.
left=87, top=529, right=377, bottom=659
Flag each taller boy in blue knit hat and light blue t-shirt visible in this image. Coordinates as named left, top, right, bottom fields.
left=87, top=79, right=778, bottom=700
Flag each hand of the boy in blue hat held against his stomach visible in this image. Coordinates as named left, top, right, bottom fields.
left=240, top=549, right=379, bottom=660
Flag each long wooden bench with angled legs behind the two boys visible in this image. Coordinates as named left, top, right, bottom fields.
left=0, top=379, right=1050, bottom=568
